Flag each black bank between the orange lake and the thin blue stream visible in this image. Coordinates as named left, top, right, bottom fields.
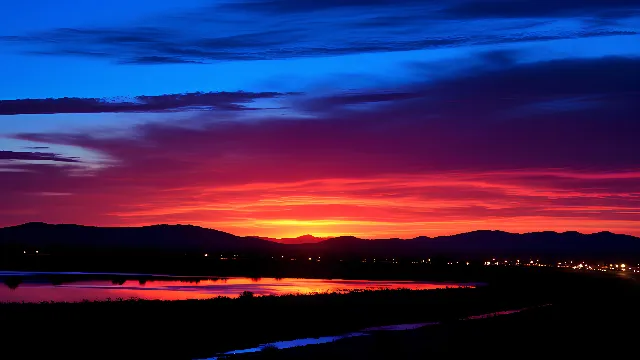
left=0, top=272, right=627, bottom=359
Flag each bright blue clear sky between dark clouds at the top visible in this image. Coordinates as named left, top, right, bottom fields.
left=0, top=0, right=640, bottom=99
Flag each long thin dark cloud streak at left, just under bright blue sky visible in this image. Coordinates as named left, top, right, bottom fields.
left=0, top=91, right=293, bottom=115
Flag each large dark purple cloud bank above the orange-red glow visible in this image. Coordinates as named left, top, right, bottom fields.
left=10, top=56, right=640, bottom=174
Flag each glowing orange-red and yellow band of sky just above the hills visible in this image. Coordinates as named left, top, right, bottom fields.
left=6, top=170, right=640, bottom=239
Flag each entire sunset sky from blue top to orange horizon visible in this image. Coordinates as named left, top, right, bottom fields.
left=0, top=0, right=640, bottom=238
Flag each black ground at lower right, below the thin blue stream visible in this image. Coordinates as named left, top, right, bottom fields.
left=225, top=276, right=640, bottom=360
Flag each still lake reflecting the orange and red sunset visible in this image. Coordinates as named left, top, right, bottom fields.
left=0, top=271, right=474, bottom=302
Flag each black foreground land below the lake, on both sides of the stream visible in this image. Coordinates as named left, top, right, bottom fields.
left=0, top=268, right=640, bottom=359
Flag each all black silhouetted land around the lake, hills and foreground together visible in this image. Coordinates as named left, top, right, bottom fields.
left=5, top=223, right=640, bottom=359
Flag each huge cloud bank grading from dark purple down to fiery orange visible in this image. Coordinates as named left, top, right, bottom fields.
left=0, top=52, right=640, bottom=237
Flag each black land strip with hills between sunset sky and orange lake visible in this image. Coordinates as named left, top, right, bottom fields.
left=0, top=223, right=640, bottom=281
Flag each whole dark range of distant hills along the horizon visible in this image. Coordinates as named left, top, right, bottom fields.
left=0, top=223, right=640, bottom=260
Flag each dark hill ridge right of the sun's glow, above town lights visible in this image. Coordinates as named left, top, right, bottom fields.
left=292, top=230, right=640, bottom=260
